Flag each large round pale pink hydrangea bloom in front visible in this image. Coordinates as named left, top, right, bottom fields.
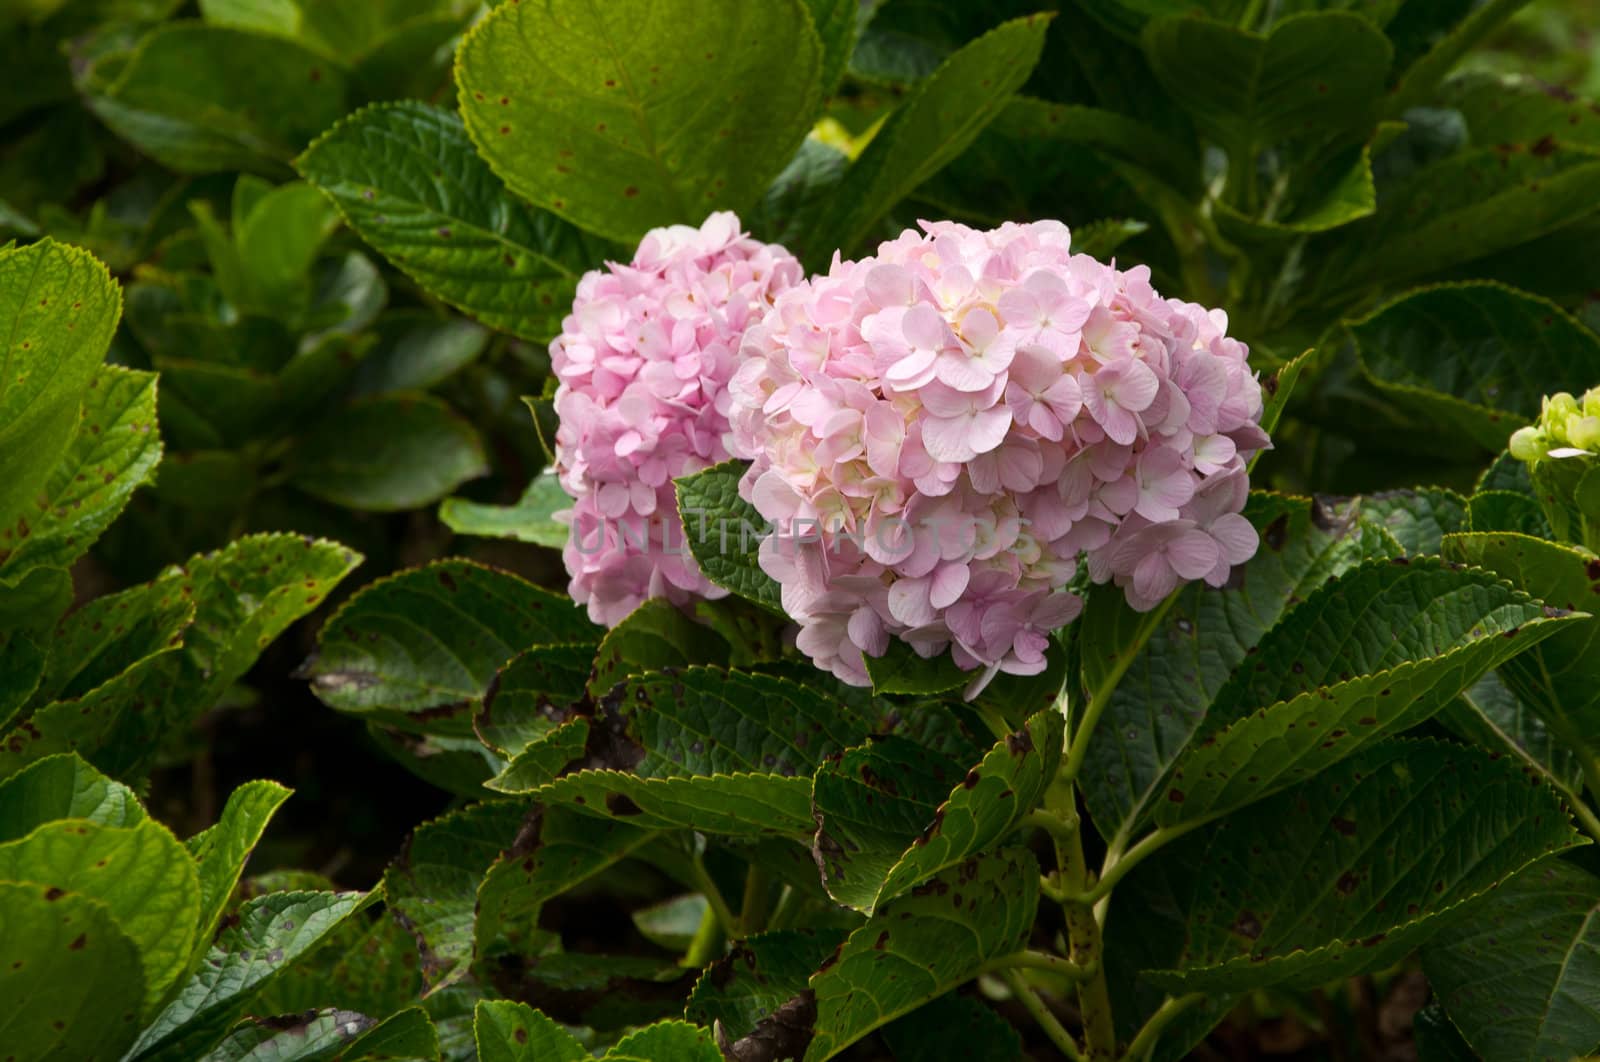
left=730, top=221, right=1269, bottom=696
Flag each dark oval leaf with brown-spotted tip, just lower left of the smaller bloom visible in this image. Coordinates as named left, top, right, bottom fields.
left=306, top=560, right=600, bottom=712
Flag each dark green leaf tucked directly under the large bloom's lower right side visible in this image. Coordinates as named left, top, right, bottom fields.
left=1075, top=491, right=1394, bottom=841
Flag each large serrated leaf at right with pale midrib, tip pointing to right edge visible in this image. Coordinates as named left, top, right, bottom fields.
left=1155, top=558, right=1584, bottom=825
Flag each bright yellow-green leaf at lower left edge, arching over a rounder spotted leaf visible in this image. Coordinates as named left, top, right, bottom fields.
left=0, top=819, right=200, bottom=1014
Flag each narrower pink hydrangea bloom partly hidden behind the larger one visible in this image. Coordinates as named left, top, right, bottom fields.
left=550, top=213, right=803, bottom=627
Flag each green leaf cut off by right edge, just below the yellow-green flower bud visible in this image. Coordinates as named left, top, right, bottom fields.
left=1445, top=533, right=1600, bottom=750
